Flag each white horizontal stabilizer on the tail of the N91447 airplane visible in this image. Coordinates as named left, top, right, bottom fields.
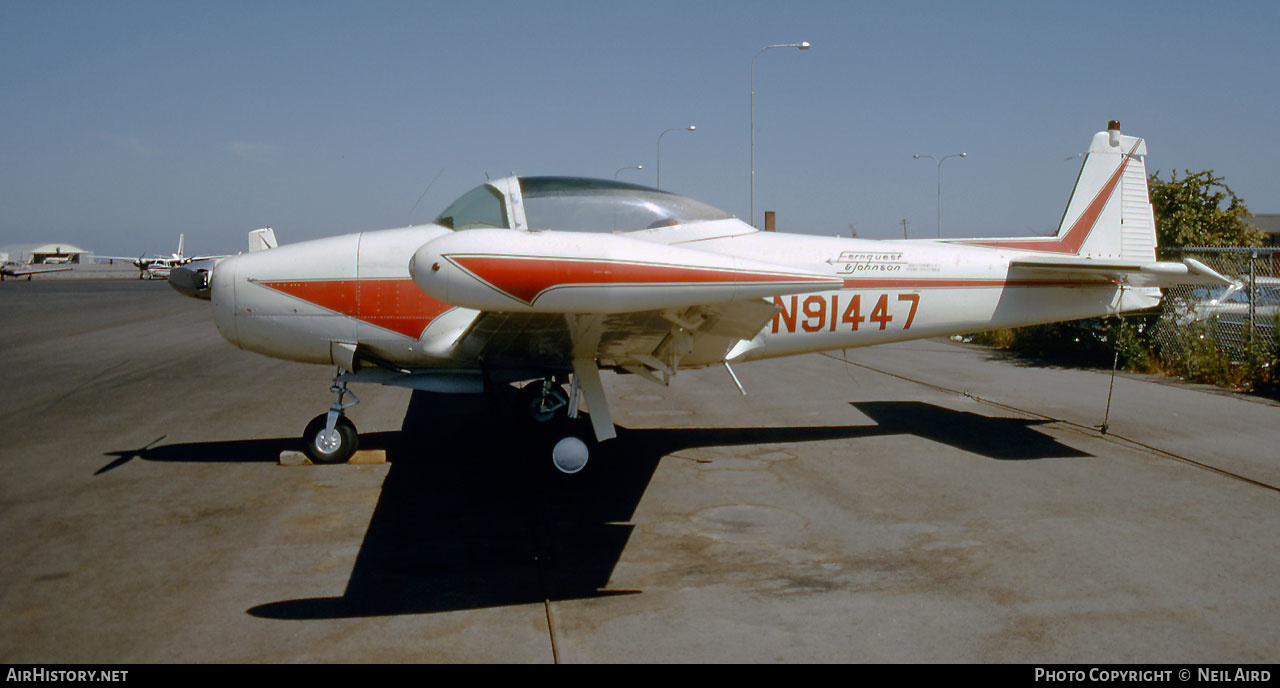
left=1010, top=257, right=1235, bottom=286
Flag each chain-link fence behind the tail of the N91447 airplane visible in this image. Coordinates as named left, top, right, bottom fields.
left=1151, top=247, right=1280, bottom=368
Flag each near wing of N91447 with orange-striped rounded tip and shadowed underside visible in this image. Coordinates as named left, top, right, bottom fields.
left=408, top=223, right=844, bottom=441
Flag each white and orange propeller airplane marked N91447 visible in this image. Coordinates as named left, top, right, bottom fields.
left=177, top=123, right=1233, bottom=472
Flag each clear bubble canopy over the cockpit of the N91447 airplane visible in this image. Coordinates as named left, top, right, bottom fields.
left=435, top=176, right=732, bottom=231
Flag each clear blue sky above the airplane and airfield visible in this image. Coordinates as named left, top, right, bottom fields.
left=0, top=0, right=1280, bottom=254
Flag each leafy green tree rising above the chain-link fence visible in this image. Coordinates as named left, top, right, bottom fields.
left=1147, top=170, right=1266, bottom=248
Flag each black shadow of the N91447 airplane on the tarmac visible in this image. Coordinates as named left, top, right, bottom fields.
left=99, top=393, right=1087, bottom=620
